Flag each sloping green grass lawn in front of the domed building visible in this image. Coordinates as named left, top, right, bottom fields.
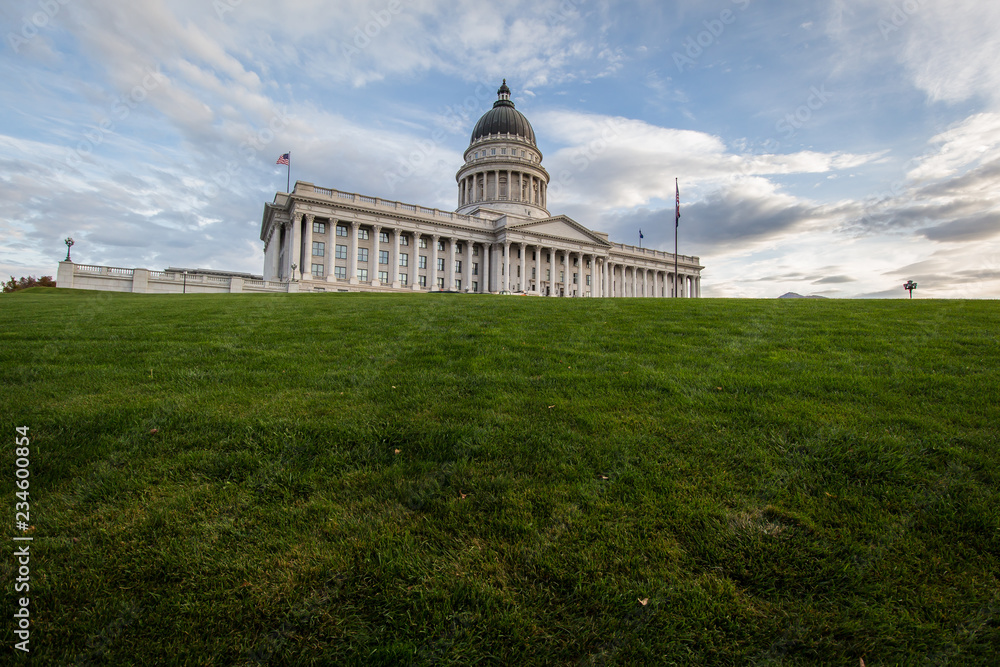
left=0, top=288, right=1000, bottom=667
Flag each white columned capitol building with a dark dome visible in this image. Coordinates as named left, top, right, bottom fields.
left=260, top=81, right=704, bottom=297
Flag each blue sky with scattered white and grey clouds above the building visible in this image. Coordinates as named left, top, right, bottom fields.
left=0, top=0, right=1000, bottom=298
